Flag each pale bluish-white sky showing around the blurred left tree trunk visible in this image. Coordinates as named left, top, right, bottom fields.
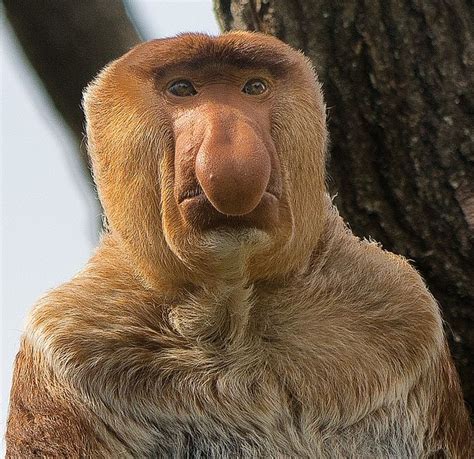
left=0, top=0, right=219, bottom=450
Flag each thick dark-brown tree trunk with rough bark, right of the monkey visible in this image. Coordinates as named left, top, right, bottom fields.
left=215, top=0, right=474, bottom=414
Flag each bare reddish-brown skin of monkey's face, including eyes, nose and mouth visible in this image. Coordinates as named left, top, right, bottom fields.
left=168, top=68, right=282, bottom=231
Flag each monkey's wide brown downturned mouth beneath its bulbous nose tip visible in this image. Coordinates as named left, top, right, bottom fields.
left=179, top=192, right=280, bottom=233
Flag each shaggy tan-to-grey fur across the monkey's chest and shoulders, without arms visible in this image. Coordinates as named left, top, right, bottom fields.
left=28, top=253, right=438, bottom=458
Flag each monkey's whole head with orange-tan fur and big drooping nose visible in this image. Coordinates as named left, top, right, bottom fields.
left=84, top=32, right=326, bottom=286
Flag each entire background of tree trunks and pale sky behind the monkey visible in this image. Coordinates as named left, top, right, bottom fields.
left=0, top=0, right=474, bottom=450
